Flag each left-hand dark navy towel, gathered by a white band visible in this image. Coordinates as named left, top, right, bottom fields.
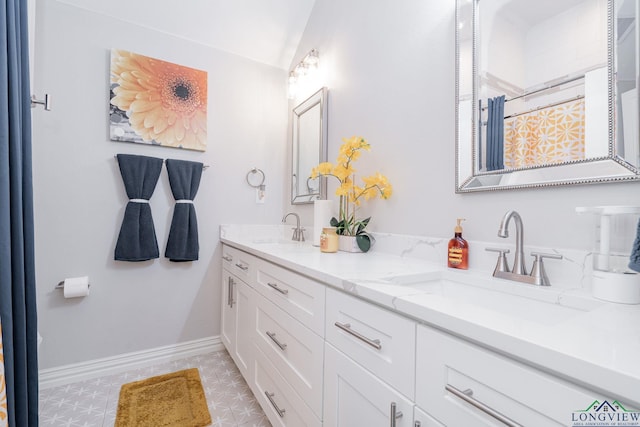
left=114, top=154, right=162, bottom=261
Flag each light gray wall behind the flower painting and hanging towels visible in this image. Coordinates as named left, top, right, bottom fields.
left=33, top=0, right=287, bottom=368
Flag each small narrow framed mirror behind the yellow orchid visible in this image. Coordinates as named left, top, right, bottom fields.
left=291, top=87, right=328, bottom=205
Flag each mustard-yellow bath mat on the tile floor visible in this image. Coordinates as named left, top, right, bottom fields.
left=115, top=368, right=211, bottom=427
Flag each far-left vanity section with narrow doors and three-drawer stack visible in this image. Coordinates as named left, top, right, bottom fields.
left=222, top=245, right=325, bottom=427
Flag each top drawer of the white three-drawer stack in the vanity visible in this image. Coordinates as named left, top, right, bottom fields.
left=256, top=260, right=325, bottom=337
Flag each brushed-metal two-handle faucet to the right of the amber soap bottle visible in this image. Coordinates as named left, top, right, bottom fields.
left=486, top=211, right=562, bottom=286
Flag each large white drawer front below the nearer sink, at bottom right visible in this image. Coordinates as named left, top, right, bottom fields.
left=416, top=325, right=602, bottom=427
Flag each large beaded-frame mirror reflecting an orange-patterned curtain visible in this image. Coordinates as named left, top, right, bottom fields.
left=456, top=0, right=640, bottom=191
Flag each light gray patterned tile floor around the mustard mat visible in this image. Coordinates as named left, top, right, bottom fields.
left=39, top=350, right=271, bottom=427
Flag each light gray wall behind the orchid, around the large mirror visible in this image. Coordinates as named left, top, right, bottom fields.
left=293, top=0, right=640, bottom=252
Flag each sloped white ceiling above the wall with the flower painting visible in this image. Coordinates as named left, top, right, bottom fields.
left=57, top=0, right=315, bottom=69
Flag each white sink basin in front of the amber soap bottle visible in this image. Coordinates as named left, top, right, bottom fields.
left=386, top=271, right=605, bottom=325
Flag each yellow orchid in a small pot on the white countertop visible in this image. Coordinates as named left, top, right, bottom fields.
left=311, top=136, right=393, bottom=252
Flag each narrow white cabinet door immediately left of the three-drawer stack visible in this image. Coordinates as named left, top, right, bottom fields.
left=234, top=280, right=256, bottom=378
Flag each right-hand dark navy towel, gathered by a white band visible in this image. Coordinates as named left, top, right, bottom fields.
left=164, top=159, right=203, bottom=262
